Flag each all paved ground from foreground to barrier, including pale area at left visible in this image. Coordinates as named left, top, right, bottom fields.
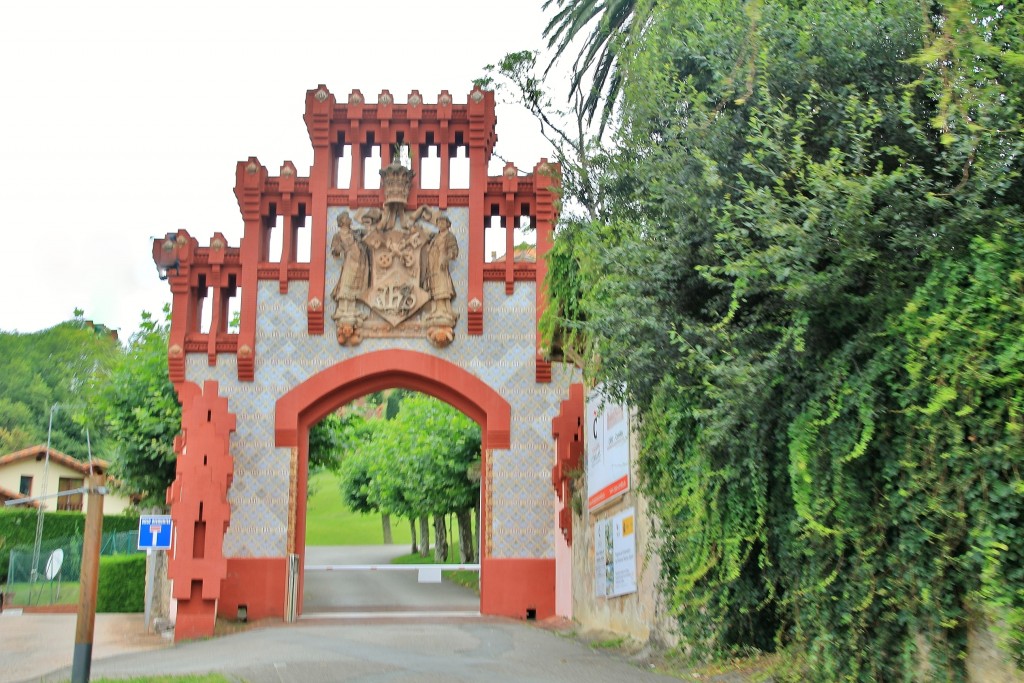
left=6, top=549, right=678, bottom=683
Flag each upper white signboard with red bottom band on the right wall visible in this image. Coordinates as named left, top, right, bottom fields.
left=587, top=387, right=630, bottom=510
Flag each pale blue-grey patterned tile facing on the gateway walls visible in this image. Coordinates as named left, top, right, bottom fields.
left=186, top=208, right=572, bottom=558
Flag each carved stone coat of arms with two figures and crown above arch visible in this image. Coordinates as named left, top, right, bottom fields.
left=331, top=163, right=459, bottom=348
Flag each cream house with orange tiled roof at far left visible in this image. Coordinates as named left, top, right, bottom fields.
left=0, top=444, right=131, bottom=515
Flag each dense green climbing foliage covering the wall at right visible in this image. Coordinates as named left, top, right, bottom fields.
left=528, top=0, right=1024, bottom=681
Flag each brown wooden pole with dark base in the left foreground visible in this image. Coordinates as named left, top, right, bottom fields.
left=71, top=474, right=105, bottom=683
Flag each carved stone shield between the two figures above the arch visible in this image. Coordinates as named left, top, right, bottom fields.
left=359, top=226, right=430, bottom=327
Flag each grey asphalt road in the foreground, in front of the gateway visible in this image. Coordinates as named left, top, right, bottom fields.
left=30, top=617, right=677, bottom=683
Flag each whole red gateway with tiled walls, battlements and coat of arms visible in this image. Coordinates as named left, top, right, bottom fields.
left=154, top=85, right=583, bottom=640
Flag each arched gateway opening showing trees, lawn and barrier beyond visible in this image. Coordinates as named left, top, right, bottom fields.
left=302, top=389, right=481, bottom=617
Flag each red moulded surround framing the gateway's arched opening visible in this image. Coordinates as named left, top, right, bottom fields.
left=274, top=350, right=511, bottom=614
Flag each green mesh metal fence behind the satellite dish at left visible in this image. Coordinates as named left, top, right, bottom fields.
left=4, top=531, right=144, bottom=607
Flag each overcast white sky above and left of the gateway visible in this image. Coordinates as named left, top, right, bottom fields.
left=0, top=0, right=551, bottom=339
